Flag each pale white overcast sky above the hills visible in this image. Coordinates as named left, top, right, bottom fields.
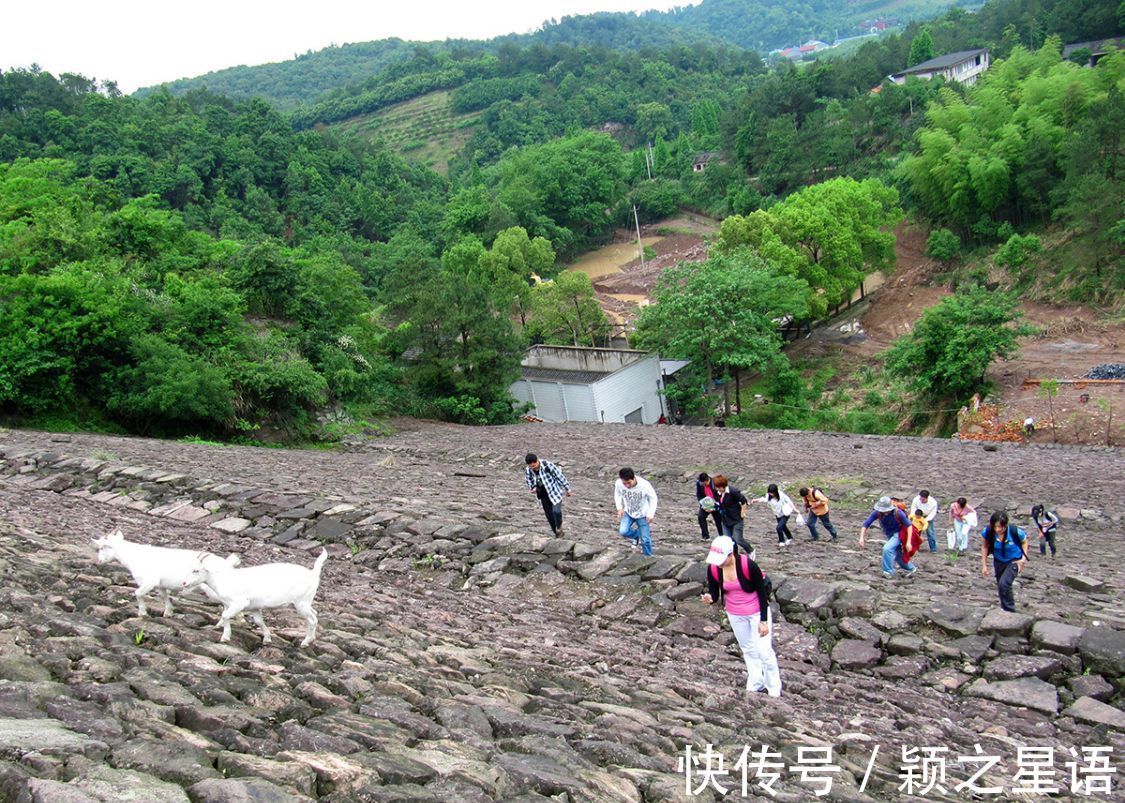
left=0, top=0, right=698, bottom=92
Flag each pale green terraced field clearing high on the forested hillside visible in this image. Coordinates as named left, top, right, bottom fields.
left=330, top=90, right=480, bottom=173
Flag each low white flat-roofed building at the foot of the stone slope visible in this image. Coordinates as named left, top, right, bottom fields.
left=511, top=345, right=664, bottom=424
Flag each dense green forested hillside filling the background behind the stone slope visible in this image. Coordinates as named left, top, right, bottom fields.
left=0, top=0, right=1125, bottom=440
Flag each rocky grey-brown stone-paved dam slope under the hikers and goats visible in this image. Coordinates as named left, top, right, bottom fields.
left=0, top=424, right=1125, bottom=803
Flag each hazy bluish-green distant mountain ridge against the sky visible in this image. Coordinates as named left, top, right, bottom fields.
left=137, top=0, right=977, bottom=109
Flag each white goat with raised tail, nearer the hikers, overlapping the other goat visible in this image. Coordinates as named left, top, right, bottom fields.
left=183, top=549, right=329, bottom=647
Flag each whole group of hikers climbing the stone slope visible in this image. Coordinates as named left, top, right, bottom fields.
left=524, top=453, right=1059, bottom=696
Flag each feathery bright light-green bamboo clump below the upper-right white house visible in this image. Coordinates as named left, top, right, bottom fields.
left=898, top=39, right=1125, bottom=238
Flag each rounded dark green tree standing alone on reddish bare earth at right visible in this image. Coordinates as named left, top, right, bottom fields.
left=887, top=286, right=1029, bottom=404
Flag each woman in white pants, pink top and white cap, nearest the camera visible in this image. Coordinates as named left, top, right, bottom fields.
left=701, top=535, right=781, bottom=697
